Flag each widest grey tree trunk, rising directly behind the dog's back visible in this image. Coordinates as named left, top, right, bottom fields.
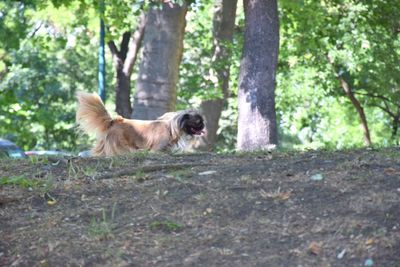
left=132, top=3, right=187, bottom=119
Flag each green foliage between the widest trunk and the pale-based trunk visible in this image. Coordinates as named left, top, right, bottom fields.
left=178, top=1, right=244, bottom=152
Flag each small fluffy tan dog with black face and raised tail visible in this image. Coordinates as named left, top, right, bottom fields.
left=76, top=92, right=205, bottom=156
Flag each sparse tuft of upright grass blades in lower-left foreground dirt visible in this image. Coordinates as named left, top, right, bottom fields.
left=88, top=203, right=117, bottom=240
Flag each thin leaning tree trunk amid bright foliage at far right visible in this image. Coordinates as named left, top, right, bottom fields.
left=327, top=55, right=372, bottom=146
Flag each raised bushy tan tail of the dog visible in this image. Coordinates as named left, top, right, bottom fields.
left=76, top=92, right=113, bottom=135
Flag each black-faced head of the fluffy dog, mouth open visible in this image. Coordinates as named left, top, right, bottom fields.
left=178, top=111, right=205, bottom=136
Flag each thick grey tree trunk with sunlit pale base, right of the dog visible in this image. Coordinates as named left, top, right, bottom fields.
left=237, top=0, right=279, bottom=151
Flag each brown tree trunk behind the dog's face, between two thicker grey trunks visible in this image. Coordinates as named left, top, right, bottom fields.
left=199, top=0, right=237, bottom=149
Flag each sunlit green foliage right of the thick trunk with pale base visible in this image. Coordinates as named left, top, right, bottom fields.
left=277, top=0, right=400, bottom=148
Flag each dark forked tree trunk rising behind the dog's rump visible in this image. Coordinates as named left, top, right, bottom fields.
left=108, top=14, right=146, bottom=118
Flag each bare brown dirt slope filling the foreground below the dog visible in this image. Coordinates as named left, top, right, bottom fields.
left=0, top=148, right=400, bottom=267
